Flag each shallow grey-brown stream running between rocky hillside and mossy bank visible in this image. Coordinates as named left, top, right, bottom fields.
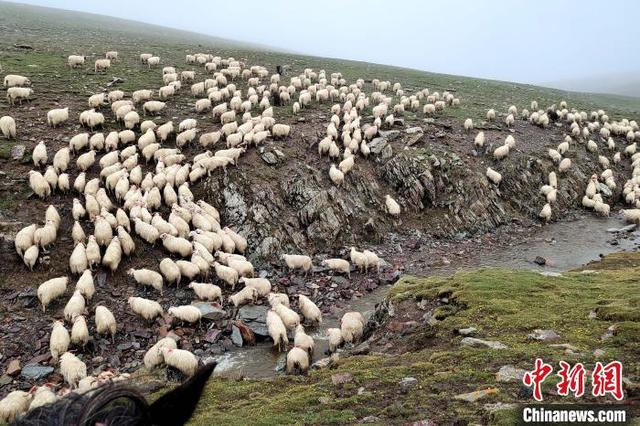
left=215, top=216, right=640, bottom=378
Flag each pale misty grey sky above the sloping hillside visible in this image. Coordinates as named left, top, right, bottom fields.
left=8, top=0, right=640, bottom=88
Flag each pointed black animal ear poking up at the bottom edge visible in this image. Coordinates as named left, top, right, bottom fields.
left=149, top=362, right=216, bottom=426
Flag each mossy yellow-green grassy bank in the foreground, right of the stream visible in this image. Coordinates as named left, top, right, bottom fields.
left=192, top=254, right=640, bottom=425
